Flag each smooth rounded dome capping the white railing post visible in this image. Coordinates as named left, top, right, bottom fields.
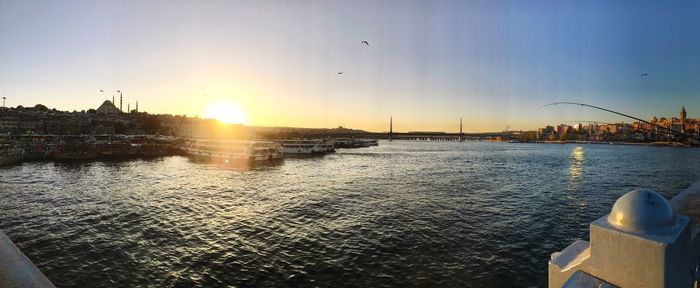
left=608, top=189, right=676, bottom=234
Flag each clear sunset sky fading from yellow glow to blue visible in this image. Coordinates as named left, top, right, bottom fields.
left=0, top=0, right=700, bottom=132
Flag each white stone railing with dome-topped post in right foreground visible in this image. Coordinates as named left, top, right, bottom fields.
left=549, top=182, right=700, bottom=288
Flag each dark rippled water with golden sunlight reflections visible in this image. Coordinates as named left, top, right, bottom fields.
left=0, top=142, right=700, bottom=287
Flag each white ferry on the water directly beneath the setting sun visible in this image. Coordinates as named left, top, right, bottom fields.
left=183, top=139, right=283, bottom=163
